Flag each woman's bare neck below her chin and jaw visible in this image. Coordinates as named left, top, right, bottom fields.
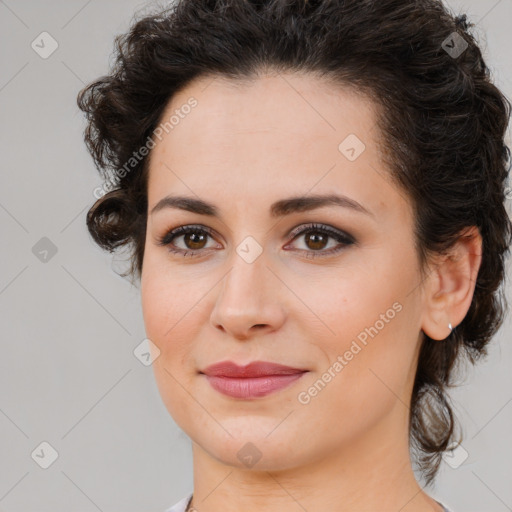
left=186, top=406, right=442, bottom=512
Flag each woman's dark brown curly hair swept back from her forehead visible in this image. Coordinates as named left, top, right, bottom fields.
left=78, top=0, right=512, bottom=485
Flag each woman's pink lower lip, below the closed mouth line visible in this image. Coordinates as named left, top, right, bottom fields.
left=206, top=372, right=306, bottom=399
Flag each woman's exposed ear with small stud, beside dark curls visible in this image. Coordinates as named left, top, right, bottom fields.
left=421, top=226, right=482, bottom=340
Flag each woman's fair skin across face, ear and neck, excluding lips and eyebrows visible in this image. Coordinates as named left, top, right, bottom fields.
left=141, top=73, right=481, bottom=512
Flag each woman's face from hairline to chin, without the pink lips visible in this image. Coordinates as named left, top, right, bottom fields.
left=141, top=74, right=424, bottom=469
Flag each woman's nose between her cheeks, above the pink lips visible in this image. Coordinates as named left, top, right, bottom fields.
left=210, top=254, right=286, bottom=340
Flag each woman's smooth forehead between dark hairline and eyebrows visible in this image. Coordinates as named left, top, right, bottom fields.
left=144, top=74, right=396, bottom=218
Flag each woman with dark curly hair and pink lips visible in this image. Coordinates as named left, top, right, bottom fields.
left=78, top=0, right=511, bottom=512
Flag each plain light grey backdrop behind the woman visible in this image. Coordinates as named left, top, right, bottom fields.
left=0, top=0, right=512, bottom=512
